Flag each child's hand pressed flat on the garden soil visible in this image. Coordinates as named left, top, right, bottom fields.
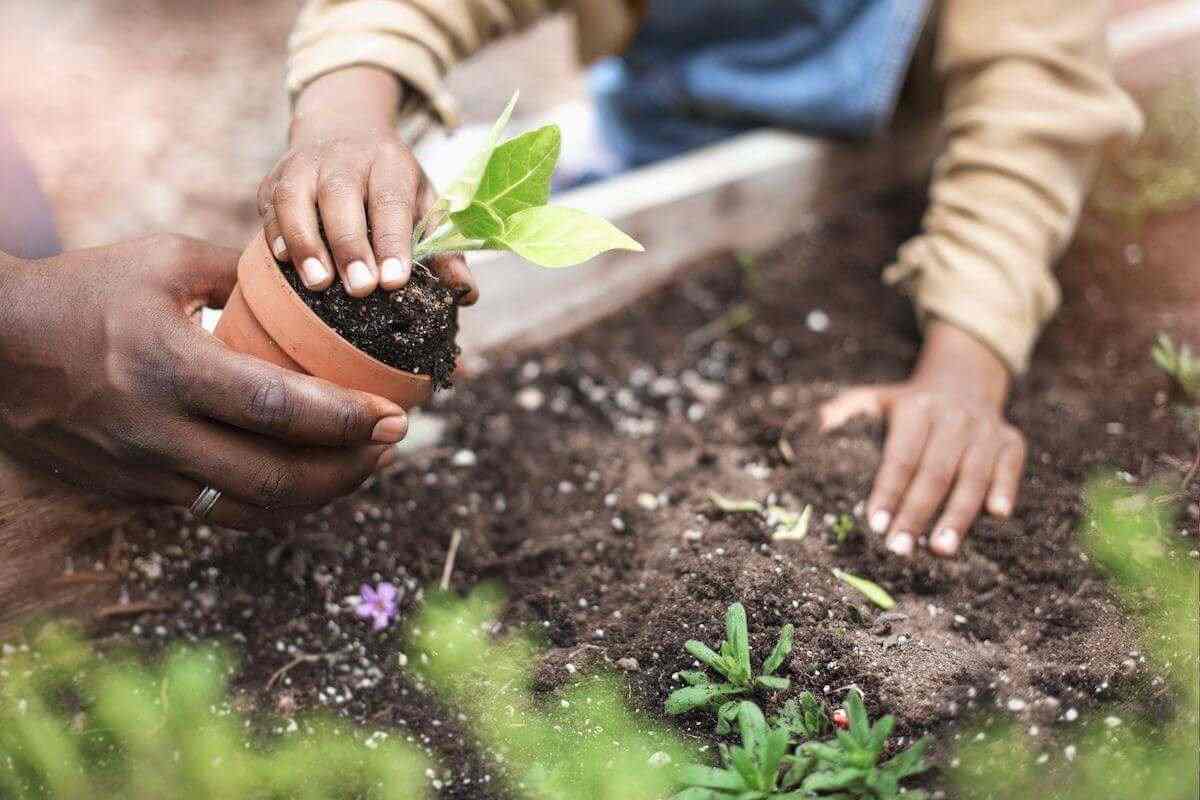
left=821, top=321, right=1026, bottom=558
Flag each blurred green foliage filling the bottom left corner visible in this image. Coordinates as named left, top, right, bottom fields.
left=0, top=628, right=426, bottom=800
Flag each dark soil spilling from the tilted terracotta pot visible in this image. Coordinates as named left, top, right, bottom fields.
left=280, top=264, right=460, bottom=389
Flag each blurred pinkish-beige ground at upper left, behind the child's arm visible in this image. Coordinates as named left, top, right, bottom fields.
left=0, top=0, right=581, bottom=247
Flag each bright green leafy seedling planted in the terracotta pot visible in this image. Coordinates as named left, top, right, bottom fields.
left=413, top=95, right=643, bottom=269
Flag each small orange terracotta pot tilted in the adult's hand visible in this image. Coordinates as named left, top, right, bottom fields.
left=215, top=234, right=433, bottom=409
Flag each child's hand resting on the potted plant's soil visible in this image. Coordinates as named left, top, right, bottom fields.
left=258, top=67, right=479, bottom=305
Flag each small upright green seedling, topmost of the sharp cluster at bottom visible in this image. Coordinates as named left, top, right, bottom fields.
left=666, top=603, right=794, bottom=734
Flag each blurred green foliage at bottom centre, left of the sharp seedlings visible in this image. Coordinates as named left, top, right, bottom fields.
left=409, top=589, right=694, bottom=800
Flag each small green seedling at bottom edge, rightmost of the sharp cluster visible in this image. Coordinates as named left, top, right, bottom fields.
left=796, top=691, right=929, bottom=800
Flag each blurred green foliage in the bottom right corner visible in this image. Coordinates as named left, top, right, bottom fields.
left=954, top=481, right=1200, bottom=800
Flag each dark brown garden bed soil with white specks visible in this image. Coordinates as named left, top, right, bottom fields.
left=87, top=185, right=1200, bottom=800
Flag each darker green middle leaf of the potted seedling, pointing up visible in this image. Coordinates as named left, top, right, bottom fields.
left=450, top=125, right=566, bottom=241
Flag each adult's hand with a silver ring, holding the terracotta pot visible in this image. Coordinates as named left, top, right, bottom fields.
left=0, top=236, right=407, bottom=524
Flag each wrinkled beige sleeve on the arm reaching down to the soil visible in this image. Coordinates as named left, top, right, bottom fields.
left=886, top=0, right=1141, bottom=372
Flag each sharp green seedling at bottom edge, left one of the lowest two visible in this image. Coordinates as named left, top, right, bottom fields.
left=674, top=702, right=814, bottom=800
